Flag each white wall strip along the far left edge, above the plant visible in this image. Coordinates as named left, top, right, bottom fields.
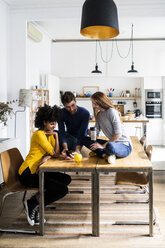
left=0, top=0, right=9, bottom=138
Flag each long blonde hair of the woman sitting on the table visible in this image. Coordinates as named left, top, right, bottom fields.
left=91, top=91, right=114, bottom=117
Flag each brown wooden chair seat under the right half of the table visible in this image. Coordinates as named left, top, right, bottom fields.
left=116, top=172, right=148, bottom=186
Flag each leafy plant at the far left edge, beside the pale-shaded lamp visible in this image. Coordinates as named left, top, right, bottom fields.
left=0, top=102, right=13, bottom=126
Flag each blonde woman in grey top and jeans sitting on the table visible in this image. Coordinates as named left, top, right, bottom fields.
left=83, top=92, right=132, bottom=163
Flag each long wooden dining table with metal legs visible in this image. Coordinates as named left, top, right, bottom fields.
left=39, top=136, right=153, bottom=237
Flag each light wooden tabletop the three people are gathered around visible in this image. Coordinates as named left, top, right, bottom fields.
left=40, top=136, right=152, bottom=172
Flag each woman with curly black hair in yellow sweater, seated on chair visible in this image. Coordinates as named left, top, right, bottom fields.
left=18, top=105, right=71, bottom=226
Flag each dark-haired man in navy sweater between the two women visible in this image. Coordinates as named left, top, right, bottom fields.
left=58, top=91, right=90, bottom=158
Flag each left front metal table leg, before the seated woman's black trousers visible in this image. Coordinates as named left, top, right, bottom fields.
left=39, top=172, right=44, bottom=236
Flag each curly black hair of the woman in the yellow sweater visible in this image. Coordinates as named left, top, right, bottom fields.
left=35, top=104, right=62, bottom=130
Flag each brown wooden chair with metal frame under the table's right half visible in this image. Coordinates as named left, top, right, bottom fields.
left=116, top=145, right=156, bottom=225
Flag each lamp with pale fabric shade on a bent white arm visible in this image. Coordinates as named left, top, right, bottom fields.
left=14, top=89, right=32, bottom=138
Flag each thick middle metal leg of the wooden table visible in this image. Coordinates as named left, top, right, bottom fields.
left=92, top=171, right=100, bottom=237
